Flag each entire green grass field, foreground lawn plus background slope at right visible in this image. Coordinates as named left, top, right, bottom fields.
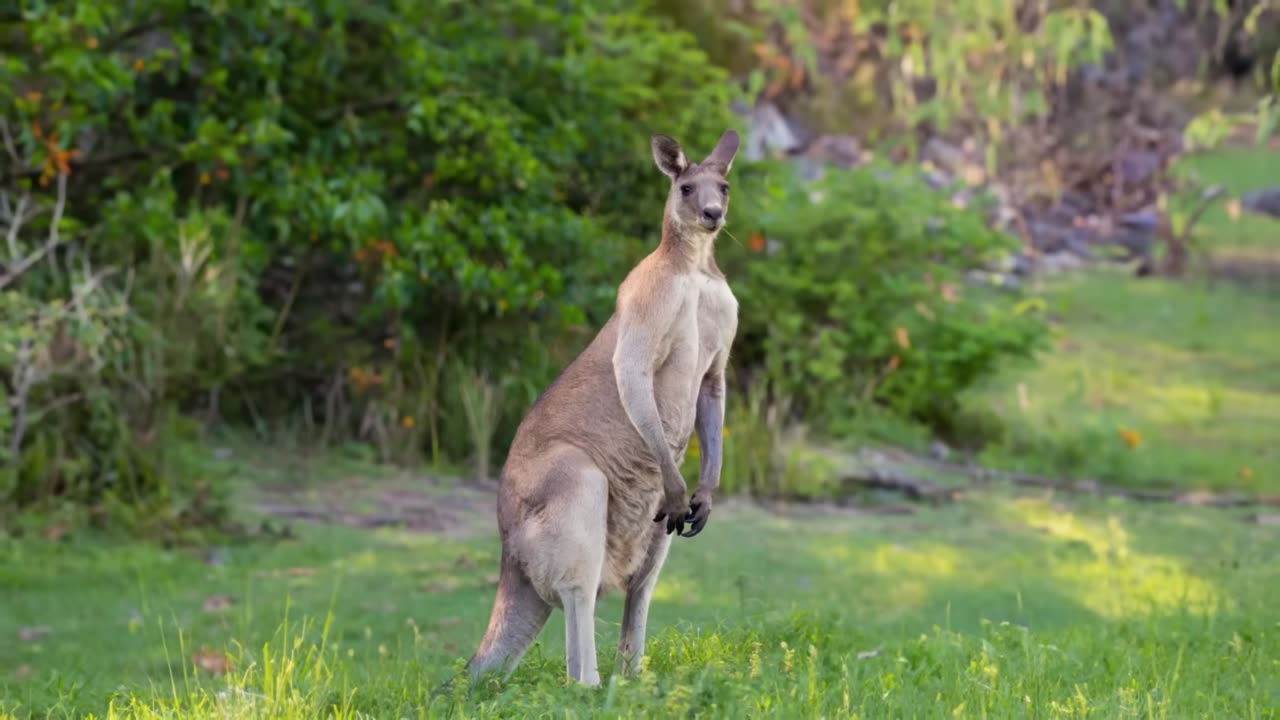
left=0, top=148, right=1280, bottom=719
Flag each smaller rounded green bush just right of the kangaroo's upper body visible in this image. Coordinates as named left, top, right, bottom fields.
left=726, top=161, right=1047, bottom=429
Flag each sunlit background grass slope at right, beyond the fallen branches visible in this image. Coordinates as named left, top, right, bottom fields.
left=966, top=149, right=1280, bottom=495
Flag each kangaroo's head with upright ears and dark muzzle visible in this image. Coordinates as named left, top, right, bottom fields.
left=650, top=129, right=737, bottom=234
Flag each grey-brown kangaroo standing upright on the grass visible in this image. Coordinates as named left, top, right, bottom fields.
left=467, top=129, right=739, bottom=685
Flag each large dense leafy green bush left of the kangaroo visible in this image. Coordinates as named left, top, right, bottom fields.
left=0, top=0, right=731, bottom=515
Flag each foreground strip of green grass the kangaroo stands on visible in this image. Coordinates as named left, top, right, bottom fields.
left=0, top=479, right=1280, bottom=717
